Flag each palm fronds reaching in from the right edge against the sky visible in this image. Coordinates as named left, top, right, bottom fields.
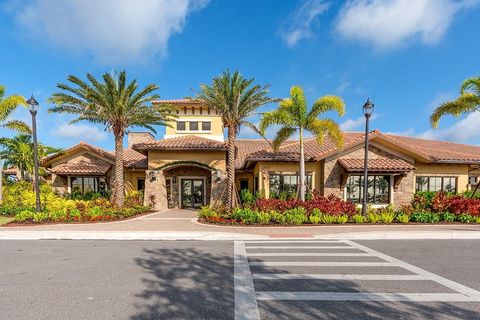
left=430, top=77, right=480, bottom=128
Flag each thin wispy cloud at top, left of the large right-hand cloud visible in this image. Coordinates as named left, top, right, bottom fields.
left=280, top=0, right=330, bottom=47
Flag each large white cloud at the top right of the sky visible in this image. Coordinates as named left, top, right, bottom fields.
left=335, top=0, right=479, bottom=49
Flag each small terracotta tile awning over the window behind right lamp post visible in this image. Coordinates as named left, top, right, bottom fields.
left=338, top=158, right=415, bottom=172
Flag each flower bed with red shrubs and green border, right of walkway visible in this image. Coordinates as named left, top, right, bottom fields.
left=199, top=193, right=480, bottom=225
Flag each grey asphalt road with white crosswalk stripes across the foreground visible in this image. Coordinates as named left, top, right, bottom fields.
left=0, top=240, right=480, bottom=320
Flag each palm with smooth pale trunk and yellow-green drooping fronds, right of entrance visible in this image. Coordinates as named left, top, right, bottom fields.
left=259, top=86, right=345, bottom=201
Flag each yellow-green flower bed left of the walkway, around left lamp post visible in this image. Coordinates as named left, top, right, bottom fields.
left=0, top=182, right=150, bottom=224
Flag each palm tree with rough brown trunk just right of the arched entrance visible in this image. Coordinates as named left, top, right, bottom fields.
left=197, top=69, right=276, bottom=209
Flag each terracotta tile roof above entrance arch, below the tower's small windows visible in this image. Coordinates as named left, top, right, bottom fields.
left=132, top=135, right=227, bottom=151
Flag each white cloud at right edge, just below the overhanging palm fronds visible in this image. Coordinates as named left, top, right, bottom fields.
left=416, top=112, right=480, bottom=143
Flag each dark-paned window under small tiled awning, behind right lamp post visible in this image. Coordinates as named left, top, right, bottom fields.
left=345, top=175, right=390, bottom=204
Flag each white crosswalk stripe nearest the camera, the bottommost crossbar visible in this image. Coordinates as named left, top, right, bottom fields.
left=257, top=291, right=480, bottom=302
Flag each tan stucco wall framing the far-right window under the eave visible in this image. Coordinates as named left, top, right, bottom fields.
left=412, top=163, right=468, bottom=192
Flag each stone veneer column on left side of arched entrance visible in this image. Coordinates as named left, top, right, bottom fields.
left=144, top=170, right=168, bottom=211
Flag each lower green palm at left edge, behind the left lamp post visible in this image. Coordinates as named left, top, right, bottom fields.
left=0, top=134, right=62, bottom=180
